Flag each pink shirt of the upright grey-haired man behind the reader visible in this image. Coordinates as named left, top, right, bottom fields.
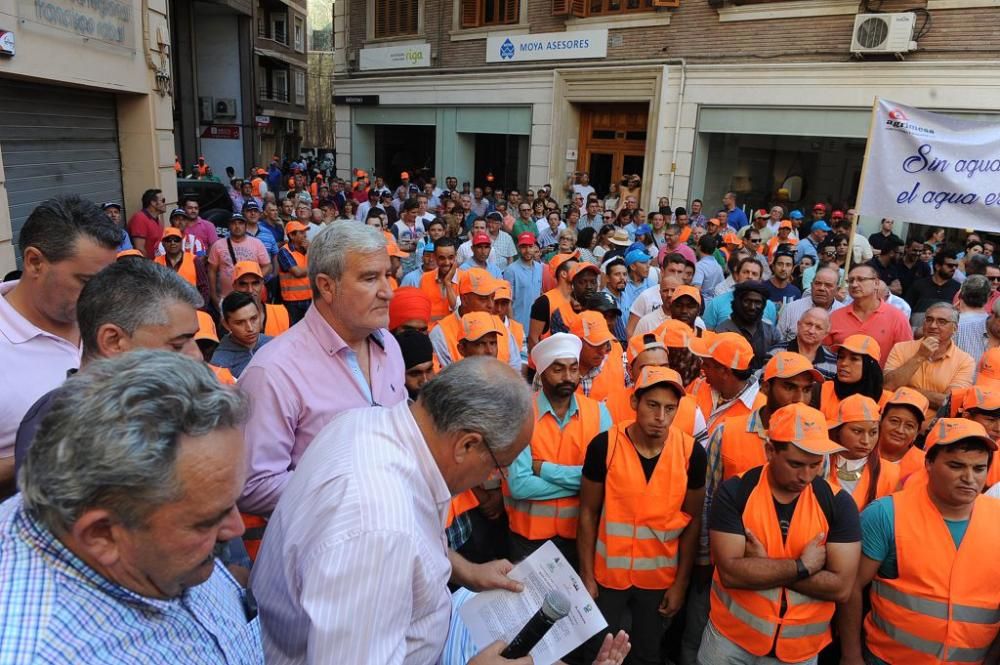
left=239, top=307, right=406, bottom=515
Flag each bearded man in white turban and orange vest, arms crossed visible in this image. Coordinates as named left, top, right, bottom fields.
left=503, top=333, right=612, bottom=568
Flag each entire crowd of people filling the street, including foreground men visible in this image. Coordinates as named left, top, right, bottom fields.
left=0, top=169, right=1000, bottom=665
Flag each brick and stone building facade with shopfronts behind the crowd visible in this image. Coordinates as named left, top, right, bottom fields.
left=334, top=0, right=1000, bottom=233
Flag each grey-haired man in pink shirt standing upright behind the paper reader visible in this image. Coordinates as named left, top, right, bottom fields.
left=240, top=224, right=407, bottom=518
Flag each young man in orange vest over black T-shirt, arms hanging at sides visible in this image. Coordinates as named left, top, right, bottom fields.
left=577, top=367, right=706, bottom=663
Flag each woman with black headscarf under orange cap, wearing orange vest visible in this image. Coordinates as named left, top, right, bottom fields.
left=813, top=335, right=892, bottom=422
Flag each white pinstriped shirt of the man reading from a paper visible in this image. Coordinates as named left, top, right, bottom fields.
left=251, top=402, right=451, bottom=665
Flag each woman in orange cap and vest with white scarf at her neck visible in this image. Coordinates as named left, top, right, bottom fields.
left=827, top=395, right=899, bottom=510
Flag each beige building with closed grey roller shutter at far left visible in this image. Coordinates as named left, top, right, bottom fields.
left=0, top=0, right=176, bottom=273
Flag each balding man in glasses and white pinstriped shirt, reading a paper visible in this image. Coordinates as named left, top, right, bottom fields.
left=251, top=357, right=533, bottom=665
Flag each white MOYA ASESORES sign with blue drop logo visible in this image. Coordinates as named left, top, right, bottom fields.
left=486, top=28, right=608, bottom=62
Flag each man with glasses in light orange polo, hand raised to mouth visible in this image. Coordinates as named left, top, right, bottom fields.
left=885, top=302, right=976, bottom=413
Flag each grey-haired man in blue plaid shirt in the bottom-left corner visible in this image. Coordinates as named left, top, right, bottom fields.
left=0, top=351, right=263, bottom=665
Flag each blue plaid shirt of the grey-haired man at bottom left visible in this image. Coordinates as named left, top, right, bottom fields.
left=0, top=495, right=264, bottom=665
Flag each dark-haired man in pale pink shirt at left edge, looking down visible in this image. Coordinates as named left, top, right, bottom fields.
left=0, top=196, right=121, bottom=500
